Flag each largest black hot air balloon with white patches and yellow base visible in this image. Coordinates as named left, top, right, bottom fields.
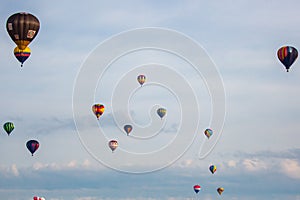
left=6, top=12, right=40, bottom=50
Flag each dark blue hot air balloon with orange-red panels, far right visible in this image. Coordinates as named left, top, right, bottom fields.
left=277, top=46, right=298, bottom=72
